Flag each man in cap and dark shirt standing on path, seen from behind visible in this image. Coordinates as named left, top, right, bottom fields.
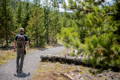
left=14, top=28, right=28, bottom=73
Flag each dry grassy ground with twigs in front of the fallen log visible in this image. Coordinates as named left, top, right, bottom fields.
left=33, top=62, right=120, bottom=80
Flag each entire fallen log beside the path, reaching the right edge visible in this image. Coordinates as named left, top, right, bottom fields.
left=40, top=55, right=120, bottom=72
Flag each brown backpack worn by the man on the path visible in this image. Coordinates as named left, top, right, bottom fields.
left=17, top=34, right=25, bottom=48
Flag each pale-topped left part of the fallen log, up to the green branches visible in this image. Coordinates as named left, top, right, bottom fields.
left=40, top=55, right=92, bottom=66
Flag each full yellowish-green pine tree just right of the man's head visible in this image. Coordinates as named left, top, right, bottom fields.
left=26, top=1, right=45, bottom=47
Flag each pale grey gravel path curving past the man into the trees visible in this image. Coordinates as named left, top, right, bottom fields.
left=0, top=46, right=65, bottom=80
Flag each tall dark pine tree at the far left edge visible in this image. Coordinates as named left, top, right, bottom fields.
left=0, top=0, right=14, bottom=46
